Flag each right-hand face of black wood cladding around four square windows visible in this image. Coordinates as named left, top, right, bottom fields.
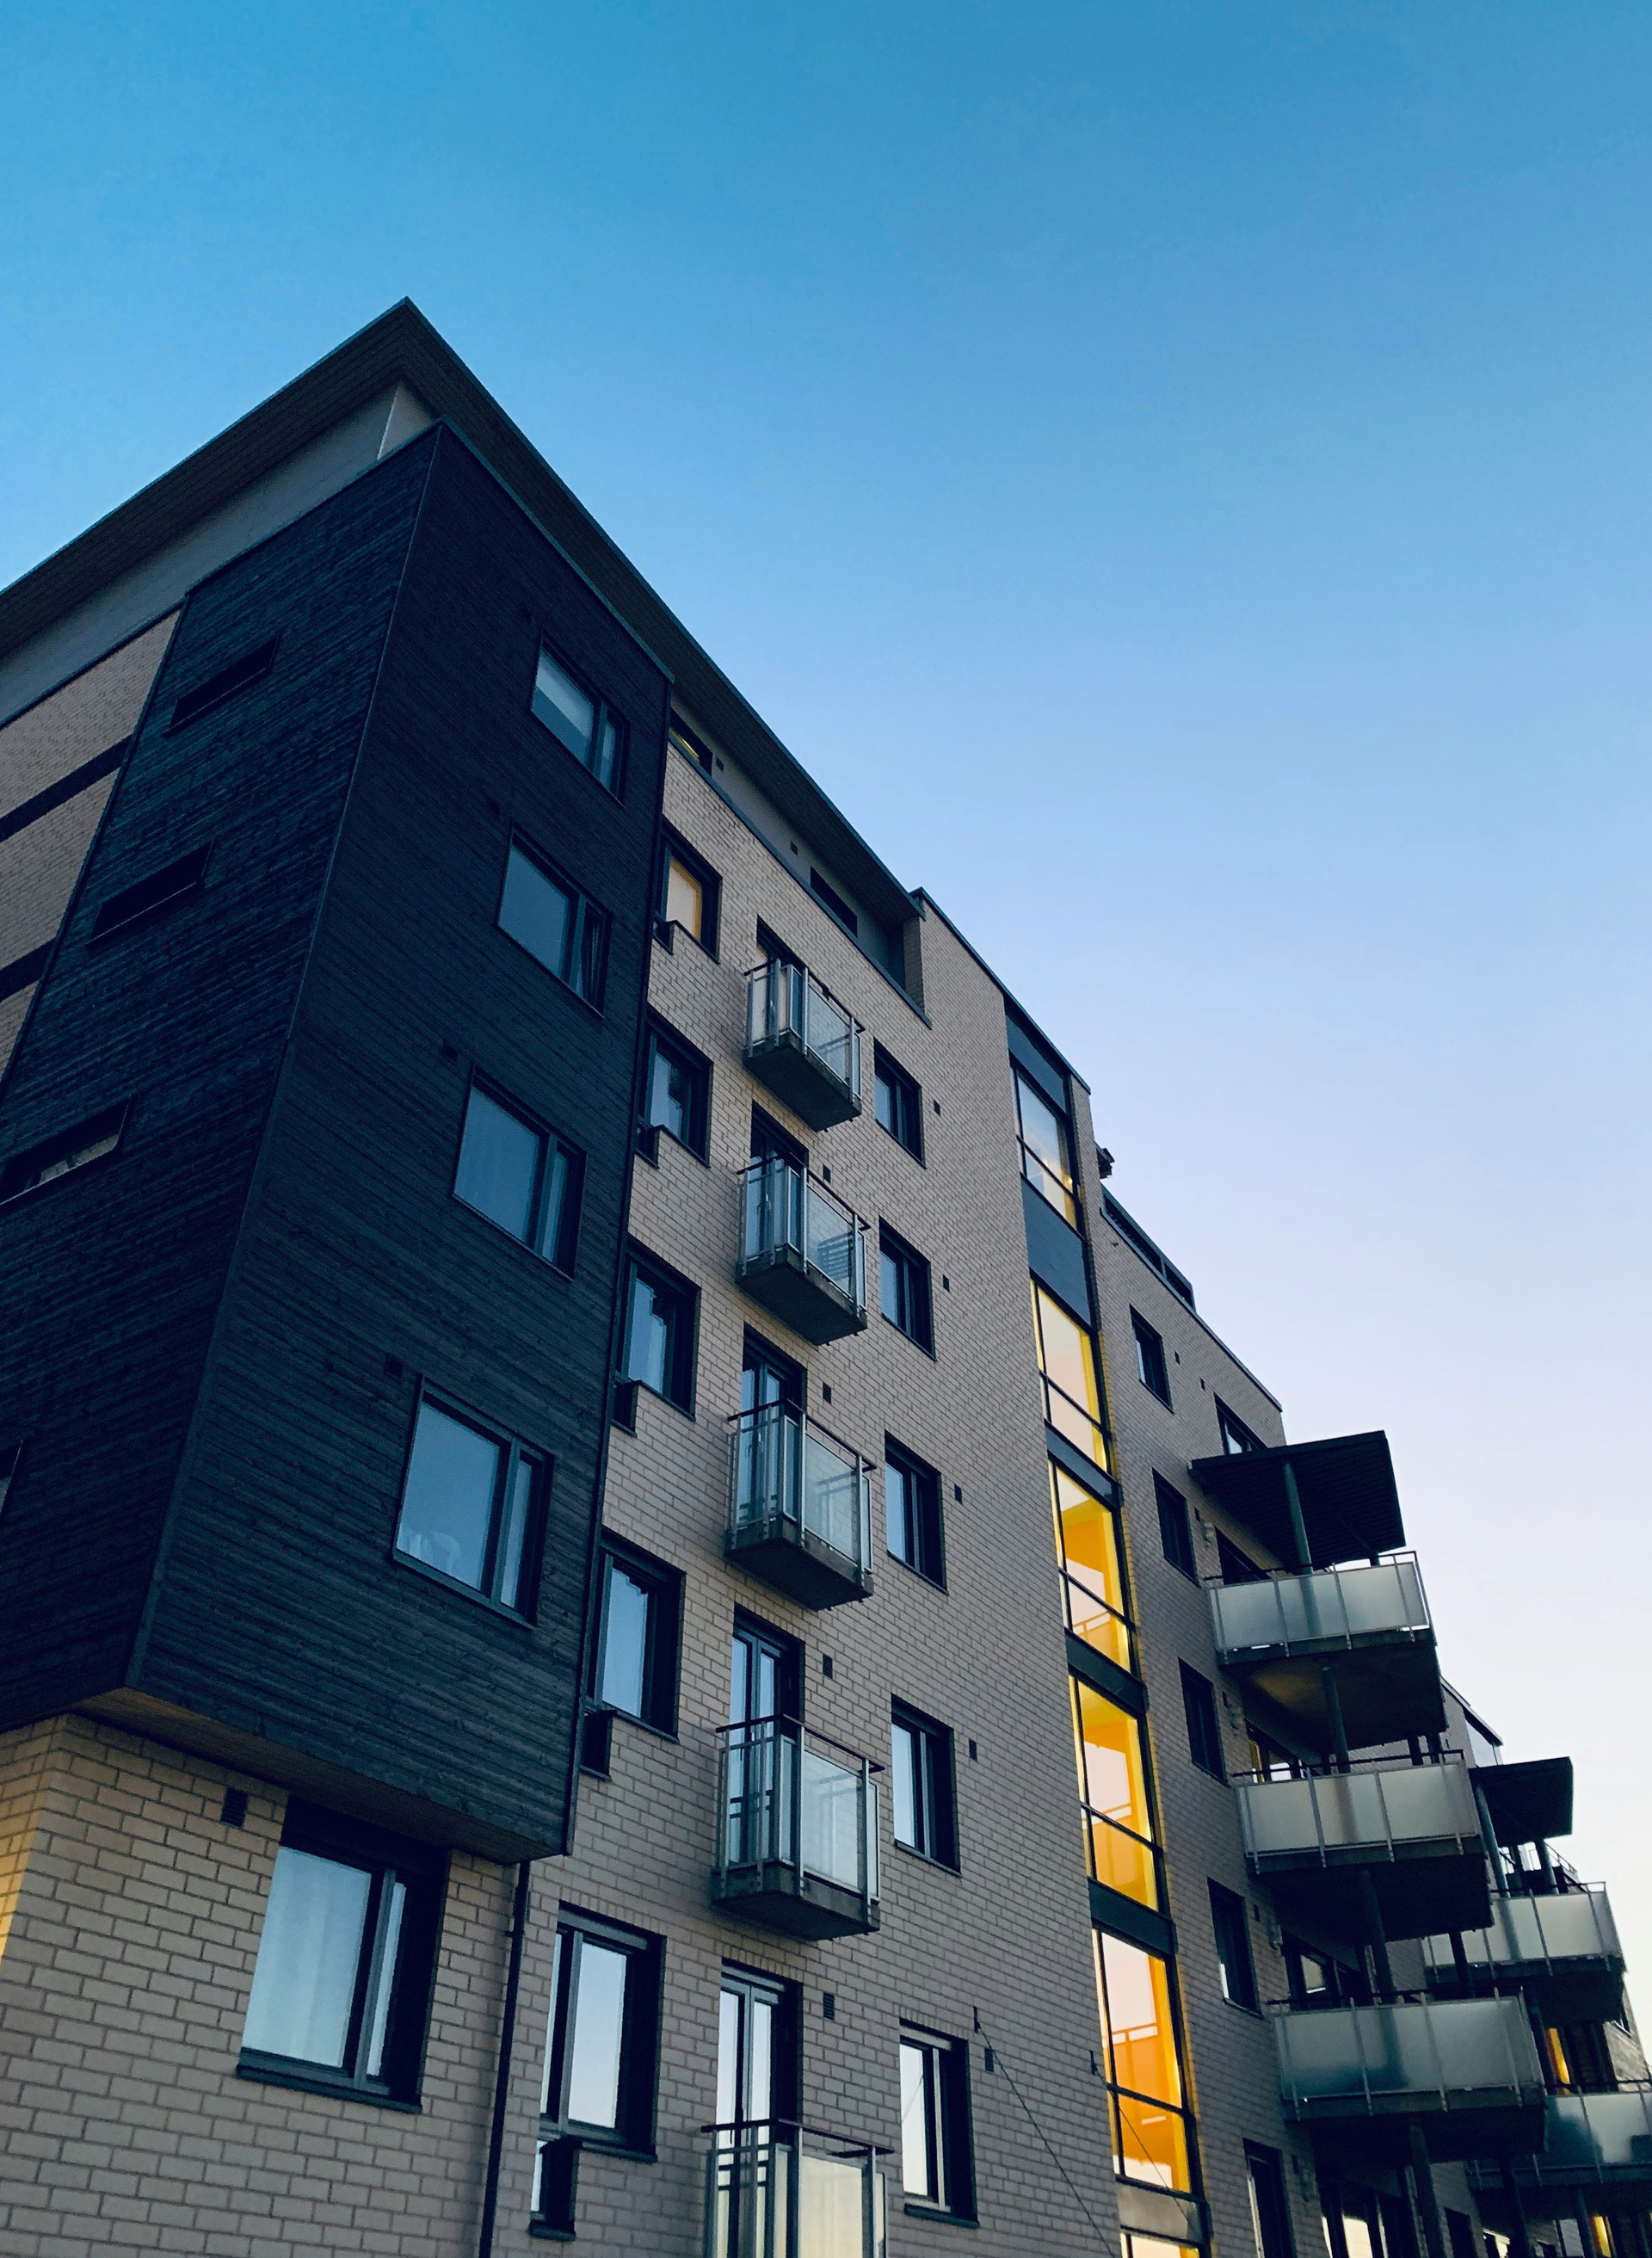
left=135, top=434, right=668, bottom=1847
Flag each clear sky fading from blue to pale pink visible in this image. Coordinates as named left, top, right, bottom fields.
left=0, top=0, right=1652, bottom=2008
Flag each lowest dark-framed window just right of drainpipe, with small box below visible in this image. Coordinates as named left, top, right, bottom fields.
left=535, top=1906, right=662, bottom=2233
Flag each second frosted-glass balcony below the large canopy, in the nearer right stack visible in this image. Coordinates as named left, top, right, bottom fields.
left=1235, top=1761, right=1492, bottom=1937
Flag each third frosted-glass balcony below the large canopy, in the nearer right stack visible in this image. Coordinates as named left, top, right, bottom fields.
left=1273, top=1998, right=1546, bottom=2161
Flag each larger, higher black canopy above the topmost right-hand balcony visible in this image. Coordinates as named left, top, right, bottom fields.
left=1189, top=1427, right=1406, bottom=1567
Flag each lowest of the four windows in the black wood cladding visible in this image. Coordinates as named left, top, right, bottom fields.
left=395, top=1396, right=551, bottom=1614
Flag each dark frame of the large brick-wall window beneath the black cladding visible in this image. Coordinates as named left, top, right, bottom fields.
left=235, top=1795, right=449, bottom=2109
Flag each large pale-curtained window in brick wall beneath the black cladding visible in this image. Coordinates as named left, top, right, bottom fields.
left=242, top=1795, right=447, bottom=2102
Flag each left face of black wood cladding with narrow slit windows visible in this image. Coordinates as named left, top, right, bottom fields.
left=0, top=441, right=434, bottom=1725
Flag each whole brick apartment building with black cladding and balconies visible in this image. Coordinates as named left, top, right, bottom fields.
left=0, top=305, right=1652, bottom=2258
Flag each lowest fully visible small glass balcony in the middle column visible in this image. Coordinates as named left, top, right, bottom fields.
left=711, top=1716, right=880, bottom=1942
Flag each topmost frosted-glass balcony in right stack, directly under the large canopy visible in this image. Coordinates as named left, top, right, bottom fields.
left=1210, top=1553, right=1445, bottom=1750
